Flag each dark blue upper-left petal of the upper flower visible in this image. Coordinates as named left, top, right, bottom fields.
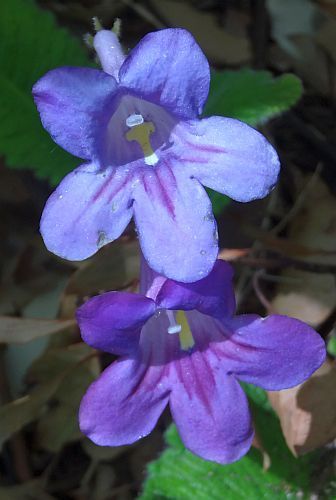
left=33, top=67, right=117, bottom=160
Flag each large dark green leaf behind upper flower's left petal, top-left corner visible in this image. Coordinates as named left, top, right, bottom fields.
left=0, top=0, right=90, bottom=184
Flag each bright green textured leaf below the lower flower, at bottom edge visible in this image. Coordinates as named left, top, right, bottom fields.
left=140, top=427, right=308, bottom=500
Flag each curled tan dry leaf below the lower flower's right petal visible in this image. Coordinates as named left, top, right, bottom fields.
left=268, top=360, right=336, bottom=456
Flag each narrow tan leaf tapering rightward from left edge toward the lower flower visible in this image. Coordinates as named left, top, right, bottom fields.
left=0, top=316, right=76, bottom=344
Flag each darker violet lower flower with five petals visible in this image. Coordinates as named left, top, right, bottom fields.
left=77, top=261, right=325, bottom=463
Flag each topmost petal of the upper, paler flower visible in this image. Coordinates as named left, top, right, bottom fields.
left=119, top=29, right=210, bottom=118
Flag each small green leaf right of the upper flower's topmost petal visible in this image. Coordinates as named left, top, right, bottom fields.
left=204, top=69, right=302, bottom=125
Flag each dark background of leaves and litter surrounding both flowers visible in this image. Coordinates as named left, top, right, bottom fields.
left=0, top=0, right=336, bottom=500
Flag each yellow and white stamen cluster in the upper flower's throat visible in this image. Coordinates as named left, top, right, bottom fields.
left=126, top=114, right=159, bottom=166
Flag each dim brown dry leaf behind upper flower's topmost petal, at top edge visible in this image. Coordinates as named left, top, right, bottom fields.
left=150, top=0, right=251, bottom=65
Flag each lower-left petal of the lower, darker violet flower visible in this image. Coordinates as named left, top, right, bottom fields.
left=79, top=359, right=168, bottom=446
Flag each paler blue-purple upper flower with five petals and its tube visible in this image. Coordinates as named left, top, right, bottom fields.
left=33, top=29, right=279, bottom=282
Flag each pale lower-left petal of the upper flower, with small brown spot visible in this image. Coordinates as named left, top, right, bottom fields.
left=41, top=164, right=133, bottom=260
